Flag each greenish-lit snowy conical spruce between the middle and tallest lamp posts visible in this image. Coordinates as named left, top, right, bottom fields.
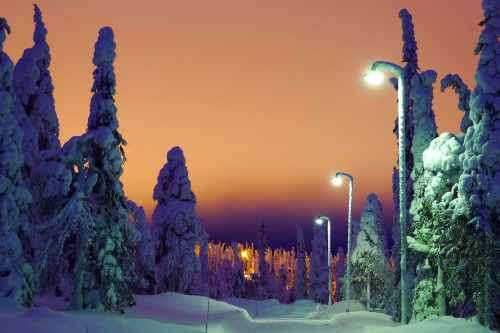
left=351, top=194, right=393, bottom=309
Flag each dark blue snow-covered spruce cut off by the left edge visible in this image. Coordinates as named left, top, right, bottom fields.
left=0, top=17, right=34, bottom=307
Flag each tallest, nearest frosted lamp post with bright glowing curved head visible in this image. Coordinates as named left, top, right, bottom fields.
left=365, top=61, right=408, bottom=325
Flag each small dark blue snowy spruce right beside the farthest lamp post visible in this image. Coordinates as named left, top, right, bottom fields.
left=309, top=226, right=329, bottom=304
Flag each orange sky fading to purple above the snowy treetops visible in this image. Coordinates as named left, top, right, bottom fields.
left=0, top=0, right=482, bottom=246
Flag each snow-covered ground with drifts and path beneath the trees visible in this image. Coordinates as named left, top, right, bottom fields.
left=0, top=293, right=491, bottom=333
